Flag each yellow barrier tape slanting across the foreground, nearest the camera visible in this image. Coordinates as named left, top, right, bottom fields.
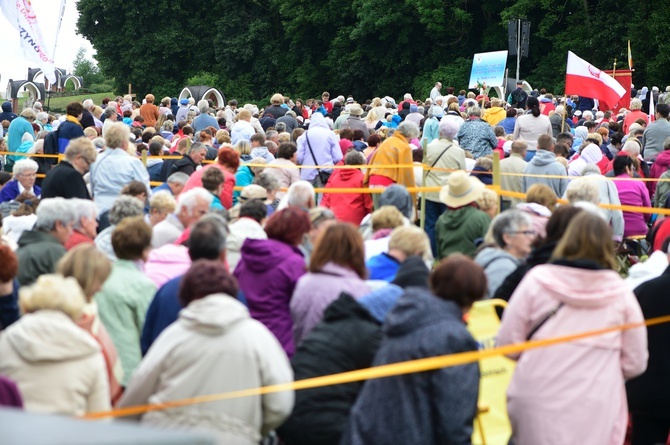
left=83, top=315, right=670, bottom=419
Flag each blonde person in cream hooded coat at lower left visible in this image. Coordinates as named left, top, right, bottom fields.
left=0, top=274, right=111, bottom=416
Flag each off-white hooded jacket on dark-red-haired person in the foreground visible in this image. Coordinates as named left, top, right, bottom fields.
left=120, top=294, right=294, bottom=445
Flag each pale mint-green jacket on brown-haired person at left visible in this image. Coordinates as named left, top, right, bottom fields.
left=95, top=260, right=156, bottom=387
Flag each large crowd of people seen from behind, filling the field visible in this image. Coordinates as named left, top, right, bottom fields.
left=0, top=82, right=670, bottom=445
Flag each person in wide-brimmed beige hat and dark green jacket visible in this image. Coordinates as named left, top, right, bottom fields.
left=435, top=171, right=491, bottom=260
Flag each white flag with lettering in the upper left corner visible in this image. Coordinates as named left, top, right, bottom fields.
left=0, top=0, right=56, bottom=84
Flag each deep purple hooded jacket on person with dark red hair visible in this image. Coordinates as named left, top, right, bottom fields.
left=235, top=238, right=305, bottom=357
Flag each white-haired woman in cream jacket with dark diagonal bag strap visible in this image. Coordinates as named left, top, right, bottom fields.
left=424, top=119, right=465, bottom=255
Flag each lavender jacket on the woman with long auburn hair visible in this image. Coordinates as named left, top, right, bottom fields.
left=291, top=263, right=372, bottom=346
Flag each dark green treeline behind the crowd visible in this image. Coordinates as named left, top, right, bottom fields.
left=77, top=0, right=670, bottom=100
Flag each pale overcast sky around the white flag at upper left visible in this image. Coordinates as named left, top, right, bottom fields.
left=0, top=0, right=94, bottom=97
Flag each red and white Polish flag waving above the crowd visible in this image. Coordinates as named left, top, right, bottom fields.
left=565, top=51, right=626, bottom=108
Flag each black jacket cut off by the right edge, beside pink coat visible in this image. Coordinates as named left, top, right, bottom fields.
left=626, top=267, right=670, bottom=418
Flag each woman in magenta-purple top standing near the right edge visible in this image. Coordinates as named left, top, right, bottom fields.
left=614, top=156, right=651, bottom=238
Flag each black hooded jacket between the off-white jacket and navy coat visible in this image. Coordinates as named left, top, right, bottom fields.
left=278, top=294, right=382, bottom=445
